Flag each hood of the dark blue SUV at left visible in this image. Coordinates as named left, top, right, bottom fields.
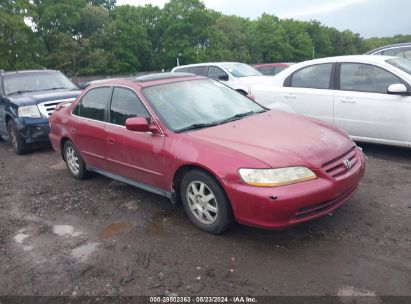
left=8, top=90, right=81, bottom=106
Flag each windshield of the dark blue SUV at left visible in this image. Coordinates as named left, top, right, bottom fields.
left=3, top=72, right=76, bottom=95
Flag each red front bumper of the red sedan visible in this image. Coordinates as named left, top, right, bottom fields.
left=223, top=148, right=365, bottom=229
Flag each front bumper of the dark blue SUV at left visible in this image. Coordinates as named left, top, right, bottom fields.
left=16, top=118, right=50, bottom=144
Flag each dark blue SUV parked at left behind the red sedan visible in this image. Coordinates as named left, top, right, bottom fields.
left=0, top=70, right=81, bottom=154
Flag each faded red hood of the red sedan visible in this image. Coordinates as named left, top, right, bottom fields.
left=187, top=110, right=355, bottom=169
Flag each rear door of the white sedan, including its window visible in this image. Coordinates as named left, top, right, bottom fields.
left=276, top=63, right=335, bottom=123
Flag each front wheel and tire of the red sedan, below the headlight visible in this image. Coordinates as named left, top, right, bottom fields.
left=180, top=170, right=234, bottom=234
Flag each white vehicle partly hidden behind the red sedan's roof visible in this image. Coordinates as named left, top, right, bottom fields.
left=171, top=62, right=270, bottom=95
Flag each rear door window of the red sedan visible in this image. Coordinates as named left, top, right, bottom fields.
left=73, top=87, right=110, bottom=121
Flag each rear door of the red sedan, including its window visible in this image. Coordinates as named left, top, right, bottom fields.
left=69, top=87, right=111, bottom=170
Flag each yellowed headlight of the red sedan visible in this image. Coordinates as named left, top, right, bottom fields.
left=238, top=167, right=317, bottom=187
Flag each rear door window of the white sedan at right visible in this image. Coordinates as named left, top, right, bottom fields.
left=290, top=63, right=332, bottom=89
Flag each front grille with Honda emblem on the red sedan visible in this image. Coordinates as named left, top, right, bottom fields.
left=322, top=147, right=359, bottom=179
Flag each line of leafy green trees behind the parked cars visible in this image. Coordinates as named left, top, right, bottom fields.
left=0, top=0, right=411, bottom=76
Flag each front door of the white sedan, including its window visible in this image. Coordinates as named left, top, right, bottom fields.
left=334, top=63, right=411, bottom=144
